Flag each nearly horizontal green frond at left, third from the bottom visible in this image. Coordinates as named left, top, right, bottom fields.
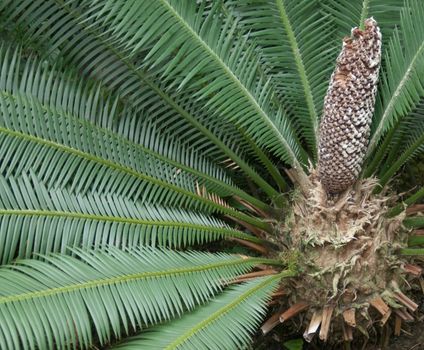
left=0, top=174, right=260, bottom=264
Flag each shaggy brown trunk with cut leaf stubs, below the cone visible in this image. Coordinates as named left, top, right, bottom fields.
left=263, top=174, right=422, bottom=341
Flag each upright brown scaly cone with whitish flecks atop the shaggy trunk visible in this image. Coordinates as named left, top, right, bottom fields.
left=318, top=18, right=381, bottom=193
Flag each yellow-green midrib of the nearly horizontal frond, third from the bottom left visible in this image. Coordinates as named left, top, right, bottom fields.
left=0, top=209, right=262, bottom=243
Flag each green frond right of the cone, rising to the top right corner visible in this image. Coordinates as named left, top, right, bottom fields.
left=368, top=0, right=424, bottom=155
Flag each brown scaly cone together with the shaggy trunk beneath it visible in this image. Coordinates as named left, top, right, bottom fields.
left=280, top=18, right=415, bottom=341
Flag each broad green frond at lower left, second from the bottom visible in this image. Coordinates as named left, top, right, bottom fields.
left=0, top=248, right=274, bottom=349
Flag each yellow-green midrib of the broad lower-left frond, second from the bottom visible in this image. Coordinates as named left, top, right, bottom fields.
left=0, top=258, right=279, bottom=304
